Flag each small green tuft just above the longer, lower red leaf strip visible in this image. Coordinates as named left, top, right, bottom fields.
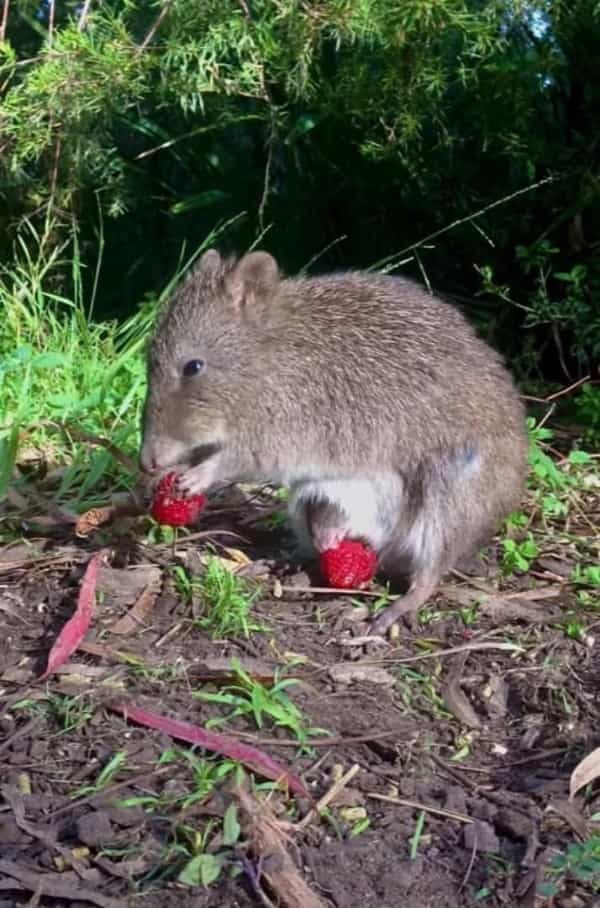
left=193, top=659, right=327, bottom=744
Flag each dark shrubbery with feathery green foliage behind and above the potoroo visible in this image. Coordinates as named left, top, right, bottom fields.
left=0, top=0, right=600, bottom=382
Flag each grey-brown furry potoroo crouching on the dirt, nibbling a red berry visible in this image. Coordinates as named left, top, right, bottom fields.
left=141, top=250, right=527, bottom=632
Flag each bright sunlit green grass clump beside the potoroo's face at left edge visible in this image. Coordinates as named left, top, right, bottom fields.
left=0, top=227, right=153, bottom=510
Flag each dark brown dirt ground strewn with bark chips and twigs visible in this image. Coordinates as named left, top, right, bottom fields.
left=0, top=478, right=600, bottom=908
